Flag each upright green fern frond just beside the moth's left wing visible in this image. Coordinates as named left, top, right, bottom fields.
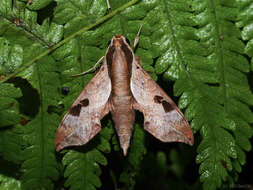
left=21, top=57, right=60, bottom=189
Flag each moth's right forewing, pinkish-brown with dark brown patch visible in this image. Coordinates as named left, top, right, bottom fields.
left=131, top=61, right=193, bottom=145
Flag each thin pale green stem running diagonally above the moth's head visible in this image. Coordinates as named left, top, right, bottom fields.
left=0, top=0, right=139, bottom=83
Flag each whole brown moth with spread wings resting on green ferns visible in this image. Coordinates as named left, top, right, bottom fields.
left=55, top=35, right=193, bottom=155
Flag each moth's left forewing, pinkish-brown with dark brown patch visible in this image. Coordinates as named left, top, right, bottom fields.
left=55, top=63, right=111, bottom=151
